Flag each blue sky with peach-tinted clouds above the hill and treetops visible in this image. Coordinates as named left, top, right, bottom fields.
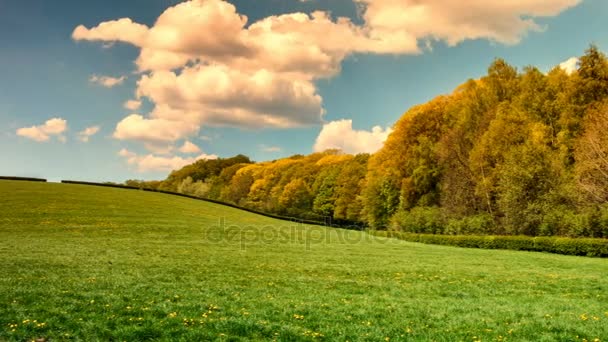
left=0, top=0, right=608, bottom=182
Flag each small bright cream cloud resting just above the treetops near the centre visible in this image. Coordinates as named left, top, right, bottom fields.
left=313, top=119, right=393, bottom=154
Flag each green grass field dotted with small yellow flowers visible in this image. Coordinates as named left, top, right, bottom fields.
left=0, top=181, right=608, bottom=341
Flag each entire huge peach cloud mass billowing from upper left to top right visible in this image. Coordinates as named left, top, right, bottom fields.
left=72, top=0, right=581, bottom=150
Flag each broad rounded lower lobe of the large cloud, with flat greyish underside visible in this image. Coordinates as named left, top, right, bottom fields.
left=137, top=65, right=324, bottom=127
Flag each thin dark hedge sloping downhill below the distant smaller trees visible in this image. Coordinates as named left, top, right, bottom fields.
left=61, top=180, right=363, bottom=229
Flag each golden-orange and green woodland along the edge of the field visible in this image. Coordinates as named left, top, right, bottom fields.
left=127, top=46, right=608, bottom=237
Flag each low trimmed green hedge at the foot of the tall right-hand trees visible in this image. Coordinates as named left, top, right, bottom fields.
left=370, top=231, right=608, bottom=258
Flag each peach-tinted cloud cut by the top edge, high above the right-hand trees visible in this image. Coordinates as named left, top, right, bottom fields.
left=355, top=0, right=582, bottom=46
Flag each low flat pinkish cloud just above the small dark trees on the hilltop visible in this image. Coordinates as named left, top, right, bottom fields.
left=118, top=148, right=217, bottom=173
